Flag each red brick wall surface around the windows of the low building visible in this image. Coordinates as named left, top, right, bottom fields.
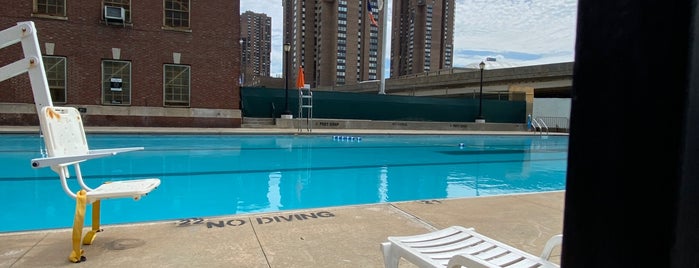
left=0, top=0, right=240, bottom=127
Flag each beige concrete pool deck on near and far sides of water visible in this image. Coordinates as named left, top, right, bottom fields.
left=0, top=127, right=565, bottom=267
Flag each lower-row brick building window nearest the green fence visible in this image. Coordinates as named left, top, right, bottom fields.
left=163, top=64, right=191, bottom=107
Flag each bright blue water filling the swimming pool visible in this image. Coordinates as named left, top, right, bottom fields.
left=0, top=134, right=568, bottom=232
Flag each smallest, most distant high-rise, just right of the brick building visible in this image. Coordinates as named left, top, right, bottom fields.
left=240, top=11, right=272, bottom=86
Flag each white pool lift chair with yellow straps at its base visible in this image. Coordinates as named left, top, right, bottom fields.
left=0, top=21, right=160, bottom=262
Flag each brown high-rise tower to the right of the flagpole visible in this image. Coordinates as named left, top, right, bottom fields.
left=391, top=0, right=454, bottom=77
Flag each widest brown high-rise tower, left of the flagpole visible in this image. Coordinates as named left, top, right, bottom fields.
left=283, top=0, right=385, bottom=88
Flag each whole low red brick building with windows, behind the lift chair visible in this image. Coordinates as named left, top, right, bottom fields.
left=0, top=0, right=241, bottom=127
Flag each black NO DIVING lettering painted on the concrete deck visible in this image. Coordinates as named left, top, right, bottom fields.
left=176, top=211, right=335, bottom=229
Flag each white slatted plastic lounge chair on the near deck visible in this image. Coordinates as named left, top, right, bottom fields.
left=381, top=226, right=563, bottom=268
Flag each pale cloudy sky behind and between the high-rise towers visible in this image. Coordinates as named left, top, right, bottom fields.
left=240, top=0, right=578, bottom=78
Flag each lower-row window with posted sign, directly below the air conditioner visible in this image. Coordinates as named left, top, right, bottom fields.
left=102, top=60, right=131, bottom=105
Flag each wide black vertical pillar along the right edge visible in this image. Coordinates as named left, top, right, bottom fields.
left=561, top=0, right=699, bottom=268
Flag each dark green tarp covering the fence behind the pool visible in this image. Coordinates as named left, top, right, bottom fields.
left=240, top=87, right=526, bottom=123
